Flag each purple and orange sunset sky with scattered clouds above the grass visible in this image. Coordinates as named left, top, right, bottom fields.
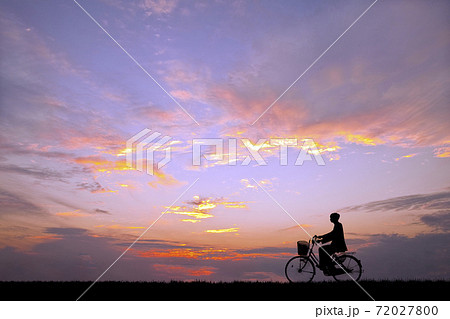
left=0, top=0, right=450, bottom=281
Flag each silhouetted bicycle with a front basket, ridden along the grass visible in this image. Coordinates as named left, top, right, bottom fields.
left=284, top=236, right=363, bottom=282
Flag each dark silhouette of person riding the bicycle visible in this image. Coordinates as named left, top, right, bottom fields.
left=317, top=213, right=347, bottom=273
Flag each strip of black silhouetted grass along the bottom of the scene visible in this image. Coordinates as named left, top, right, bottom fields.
left=0, top=280, right=450, bottom=301
